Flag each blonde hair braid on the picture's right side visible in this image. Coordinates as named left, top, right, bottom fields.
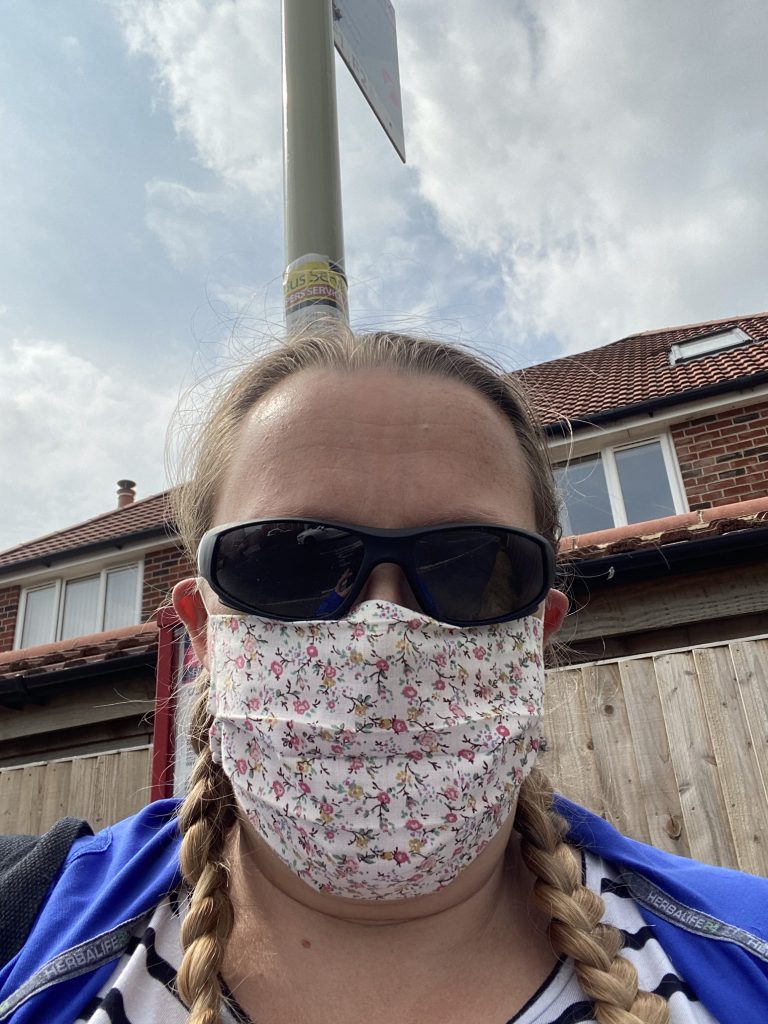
left=515, top=768, right=670, bottom=1024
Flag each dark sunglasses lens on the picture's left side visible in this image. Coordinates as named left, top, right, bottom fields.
left=214, top=520, right=364, bottom=620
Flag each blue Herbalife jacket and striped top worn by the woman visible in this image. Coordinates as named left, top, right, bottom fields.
left=0, top=799, right=768, bottom=1024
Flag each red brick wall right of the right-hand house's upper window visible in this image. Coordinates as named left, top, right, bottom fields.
left=671, top=401, right=768, bottom=510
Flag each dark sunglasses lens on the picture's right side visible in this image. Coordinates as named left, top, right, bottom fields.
left=415, top=527, right=546, bottom=623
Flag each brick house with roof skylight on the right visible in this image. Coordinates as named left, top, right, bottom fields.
left=517, top=313, right=768, bottom=662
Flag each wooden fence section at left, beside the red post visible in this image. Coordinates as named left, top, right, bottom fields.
left=0, top=746, right=152, bottom=836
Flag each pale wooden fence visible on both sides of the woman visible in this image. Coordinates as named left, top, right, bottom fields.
left=0, top=637, right=768, bottom=874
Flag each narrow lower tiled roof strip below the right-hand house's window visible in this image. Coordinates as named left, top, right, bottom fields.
left=558, top=498, right=768, bottom=564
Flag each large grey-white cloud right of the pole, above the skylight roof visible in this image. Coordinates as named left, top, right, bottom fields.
left=401, top=0, right=768, bottom=349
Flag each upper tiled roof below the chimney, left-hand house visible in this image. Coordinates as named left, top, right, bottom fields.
left=0, top=492, right=170, bottom=571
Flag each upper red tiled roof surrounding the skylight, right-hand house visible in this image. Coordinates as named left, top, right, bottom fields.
left=513, top=313, right=768, bottom=424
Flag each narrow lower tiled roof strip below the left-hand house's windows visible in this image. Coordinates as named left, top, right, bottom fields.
left=0, top=623, right=158, bottom=680
